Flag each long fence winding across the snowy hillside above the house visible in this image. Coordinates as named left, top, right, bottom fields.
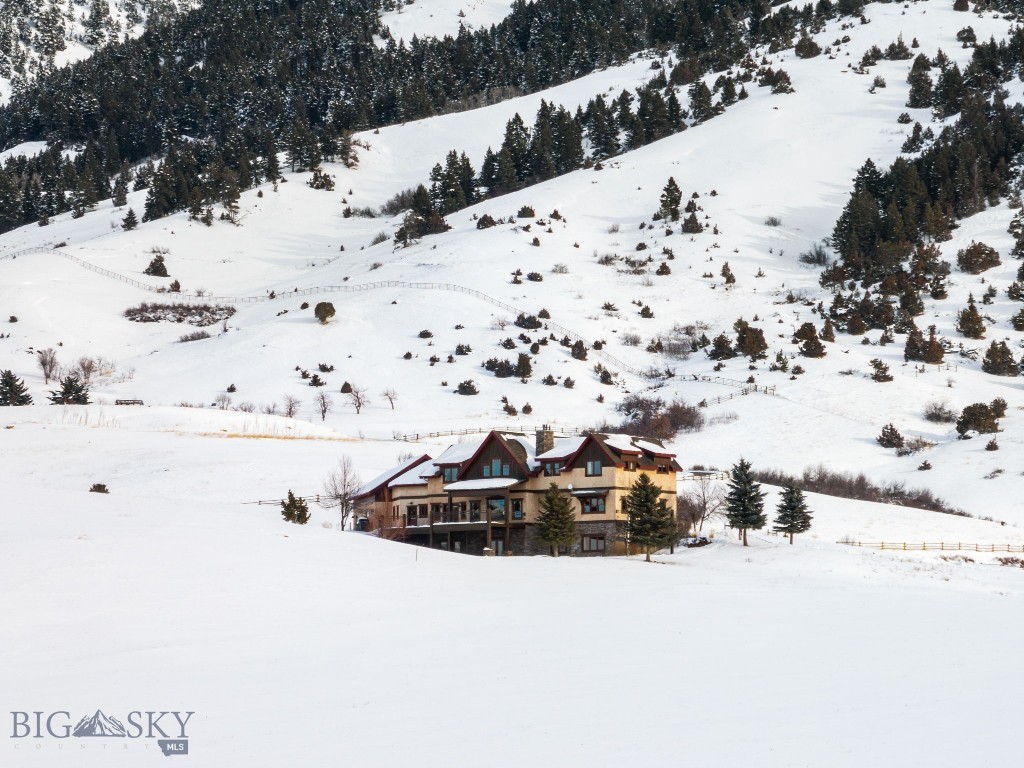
left=0, top=247, right=775, bottom=393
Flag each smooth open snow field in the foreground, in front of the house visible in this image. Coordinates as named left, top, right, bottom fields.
left=0, top=407, right=1024, bottom=768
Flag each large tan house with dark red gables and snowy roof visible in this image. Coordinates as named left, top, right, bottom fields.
left=355, top=427, right=680, bottom=555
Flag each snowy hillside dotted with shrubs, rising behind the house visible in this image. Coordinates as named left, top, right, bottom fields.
left=0, top=3, right=1024, bottom=522
